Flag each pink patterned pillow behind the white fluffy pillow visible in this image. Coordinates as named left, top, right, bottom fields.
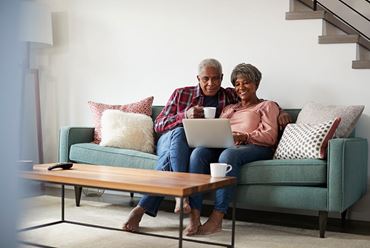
left=88, top=96, right=154, bottom=144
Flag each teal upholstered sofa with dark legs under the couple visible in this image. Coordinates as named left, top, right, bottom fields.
left=59, top=106, right=368, bottom=237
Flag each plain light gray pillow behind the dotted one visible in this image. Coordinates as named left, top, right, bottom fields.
left=296, top=102, right=365, bottom=138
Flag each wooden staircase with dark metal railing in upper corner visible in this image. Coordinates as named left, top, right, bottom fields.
left=285, top=0, right=370, bottom=69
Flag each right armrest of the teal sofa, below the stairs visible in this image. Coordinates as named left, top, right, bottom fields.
left=327, top=138, right=368, bottom=212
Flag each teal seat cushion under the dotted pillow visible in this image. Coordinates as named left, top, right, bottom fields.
left=238, top=159, right=326, bottom=186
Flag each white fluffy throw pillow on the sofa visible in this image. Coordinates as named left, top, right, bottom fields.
left=100, top=110, right=154, bottom=153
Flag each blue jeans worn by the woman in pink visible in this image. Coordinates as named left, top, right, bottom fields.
left=189, top=144, right=273, bottom=213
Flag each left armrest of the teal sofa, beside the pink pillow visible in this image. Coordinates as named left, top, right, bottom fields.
left=58, top=127, right=94, bottom=162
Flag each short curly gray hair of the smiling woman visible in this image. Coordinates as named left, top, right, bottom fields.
left=231, top=63, right=262, bottom=87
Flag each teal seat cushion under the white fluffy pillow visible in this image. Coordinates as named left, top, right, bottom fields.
left=69, top=143, right=157, bottom=169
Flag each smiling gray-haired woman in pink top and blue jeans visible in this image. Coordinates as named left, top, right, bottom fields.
left=184, top=63, right=279, bottom=236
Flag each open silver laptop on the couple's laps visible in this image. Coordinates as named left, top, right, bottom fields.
left=182, top=119, right=234, bottom=148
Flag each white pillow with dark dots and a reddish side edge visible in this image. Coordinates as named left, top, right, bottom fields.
left=274, top=118, right=341, bottom=159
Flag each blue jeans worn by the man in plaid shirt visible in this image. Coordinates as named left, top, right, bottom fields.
left=139, top=127, right=190, bottom=217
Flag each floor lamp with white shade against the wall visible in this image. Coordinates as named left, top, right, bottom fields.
left=20, top=1, right=53, bottom=163
